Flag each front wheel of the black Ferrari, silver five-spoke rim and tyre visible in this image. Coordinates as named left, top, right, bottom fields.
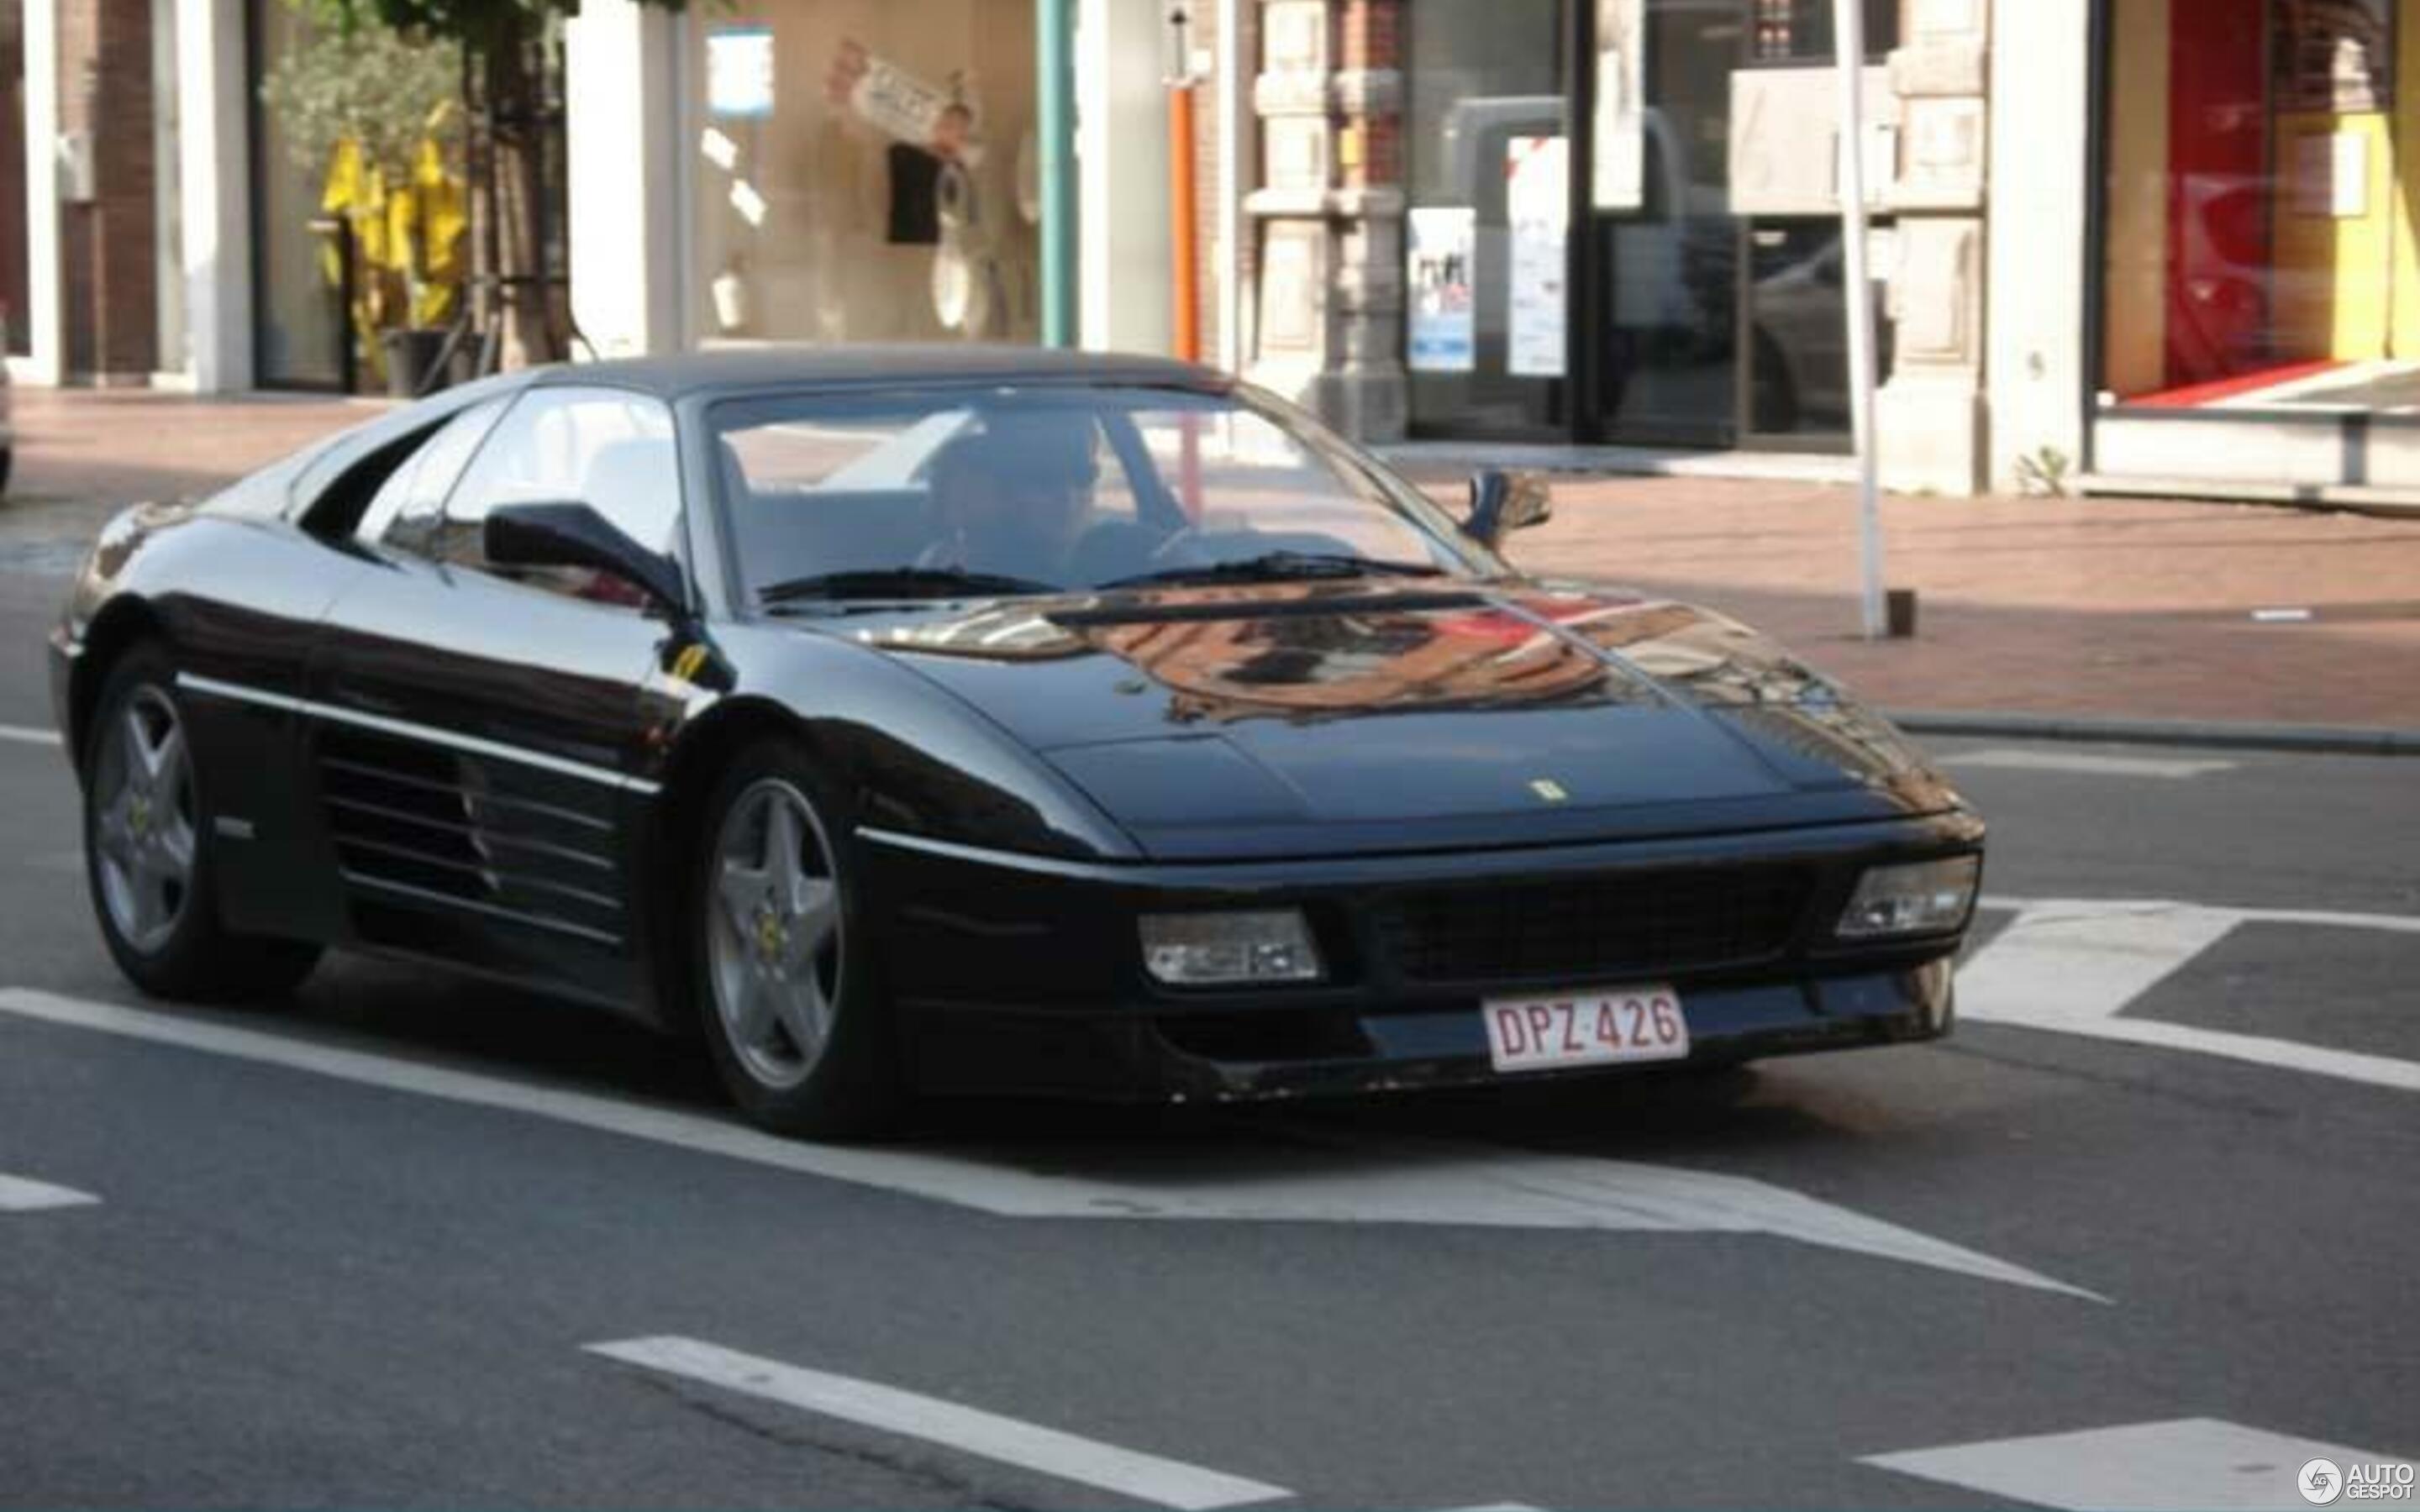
left=687, top=743, right=900, bottom=1137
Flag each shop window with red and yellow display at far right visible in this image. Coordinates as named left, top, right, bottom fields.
left=2101, top=0, right=2420, bottom=412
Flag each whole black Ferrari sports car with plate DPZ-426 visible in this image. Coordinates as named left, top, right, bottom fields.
left=50, top=349, right=1985, bottom=1132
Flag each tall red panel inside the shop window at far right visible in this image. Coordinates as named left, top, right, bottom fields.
left=2168, top=0, right=2275, bottom=387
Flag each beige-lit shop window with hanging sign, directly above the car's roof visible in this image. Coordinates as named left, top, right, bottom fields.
left=687, top=0, right=1040, bottom=344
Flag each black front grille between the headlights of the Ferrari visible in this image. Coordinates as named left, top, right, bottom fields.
left=1375, top=866, right=1815, bottom=982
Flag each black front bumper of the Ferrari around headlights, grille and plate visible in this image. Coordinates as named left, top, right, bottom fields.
left=859, top=813, right=1982, bottom=1100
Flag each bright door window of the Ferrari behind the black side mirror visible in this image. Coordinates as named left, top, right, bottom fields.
left=429, top=385, right=680, bottom=583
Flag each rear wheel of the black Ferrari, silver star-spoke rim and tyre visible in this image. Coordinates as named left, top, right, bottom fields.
left=80, top=646, right=319, bottom=1001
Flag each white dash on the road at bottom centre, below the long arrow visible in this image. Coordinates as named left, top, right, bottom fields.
left=588, top=1338, right=1292, bottom=1512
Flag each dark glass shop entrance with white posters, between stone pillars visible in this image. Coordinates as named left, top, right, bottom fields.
left=1403, top=0, right=1897, bottom=450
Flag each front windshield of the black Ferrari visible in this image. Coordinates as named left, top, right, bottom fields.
left=709, top=385, right=1502, bottom=607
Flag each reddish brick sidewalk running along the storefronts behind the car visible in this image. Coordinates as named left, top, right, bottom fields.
left=0, top=387, right=2420, bottom=728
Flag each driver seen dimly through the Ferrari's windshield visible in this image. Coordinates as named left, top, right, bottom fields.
left=918, top=412, right=1099, bottom=585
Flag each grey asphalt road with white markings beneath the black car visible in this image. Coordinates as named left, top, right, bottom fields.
left=0, top=556, right=2420, bottom=1507
